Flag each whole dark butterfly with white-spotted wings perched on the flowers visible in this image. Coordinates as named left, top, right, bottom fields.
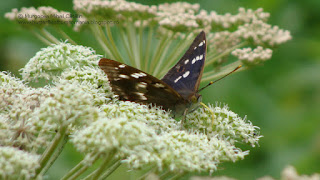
left=99, top=31, right=207, bottom=117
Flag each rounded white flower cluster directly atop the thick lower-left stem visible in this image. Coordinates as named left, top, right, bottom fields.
left=32, top=81, right=99, bottom=133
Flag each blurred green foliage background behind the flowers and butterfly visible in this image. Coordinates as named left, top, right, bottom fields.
left=0, top=0, right=320, bottom=179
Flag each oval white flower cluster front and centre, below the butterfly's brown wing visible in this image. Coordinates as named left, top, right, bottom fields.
left=71, top=118, right=156, bottom=155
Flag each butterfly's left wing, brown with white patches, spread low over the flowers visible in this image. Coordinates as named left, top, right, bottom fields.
left=99, top=58, right=186, bottom=110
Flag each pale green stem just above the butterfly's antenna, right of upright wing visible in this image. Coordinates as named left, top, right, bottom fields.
left=201, top=60, right=247, bottom=82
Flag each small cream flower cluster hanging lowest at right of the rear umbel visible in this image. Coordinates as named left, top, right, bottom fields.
left=231, top=46, right=272, bottom=65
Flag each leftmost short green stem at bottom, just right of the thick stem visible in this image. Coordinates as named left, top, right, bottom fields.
left=61, top=155, right=99, bottom=180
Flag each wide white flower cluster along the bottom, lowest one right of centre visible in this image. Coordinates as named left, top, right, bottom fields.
left=124, top=131, right=248, bottom=173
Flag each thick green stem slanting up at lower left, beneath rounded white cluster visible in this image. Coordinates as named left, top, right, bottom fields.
left=36, top=126, right=67, bottom=177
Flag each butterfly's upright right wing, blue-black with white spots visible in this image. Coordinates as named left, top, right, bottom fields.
left=162, top=31, right=207, bottom=99
